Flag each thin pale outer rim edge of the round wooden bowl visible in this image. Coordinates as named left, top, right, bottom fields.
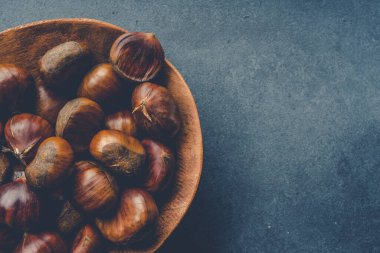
left=0, top=18, right=203, bottom=252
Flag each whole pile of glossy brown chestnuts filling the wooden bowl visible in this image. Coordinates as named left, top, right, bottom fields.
left=0, top=32, right=181, bottom=253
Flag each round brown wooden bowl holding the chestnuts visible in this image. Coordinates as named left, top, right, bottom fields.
left=0, top=19, right=203, bottom=253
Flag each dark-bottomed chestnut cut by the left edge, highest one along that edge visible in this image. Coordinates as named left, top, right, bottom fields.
left=0, top=64, right=34, bottom=118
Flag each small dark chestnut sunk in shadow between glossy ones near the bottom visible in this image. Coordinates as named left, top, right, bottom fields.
left=57, top=201, right=84, bottom=234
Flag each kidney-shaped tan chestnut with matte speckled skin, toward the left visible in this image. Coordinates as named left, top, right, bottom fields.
left=25, top=137, right=74, bottom=189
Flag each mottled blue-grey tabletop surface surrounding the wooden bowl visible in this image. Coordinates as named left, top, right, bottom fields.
left=0, top=0, right=380, bottom=253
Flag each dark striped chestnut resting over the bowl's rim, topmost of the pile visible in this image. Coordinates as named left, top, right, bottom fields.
left=110, top=32, right=165, bottom=82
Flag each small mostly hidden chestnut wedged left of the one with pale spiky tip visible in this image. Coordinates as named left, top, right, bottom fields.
left=106, top=111, right=137, bottom=137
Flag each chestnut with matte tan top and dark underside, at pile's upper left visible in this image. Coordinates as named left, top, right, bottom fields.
left=39, top=41, right=91, bottom=90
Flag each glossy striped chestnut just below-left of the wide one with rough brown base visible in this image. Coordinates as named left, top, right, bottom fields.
left=72, top=161, right=119, bottom=213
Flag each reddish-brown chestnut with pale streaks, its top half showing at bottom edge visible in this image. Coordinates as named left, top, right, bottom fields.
left=13, top=232, right=67, bottom=253
